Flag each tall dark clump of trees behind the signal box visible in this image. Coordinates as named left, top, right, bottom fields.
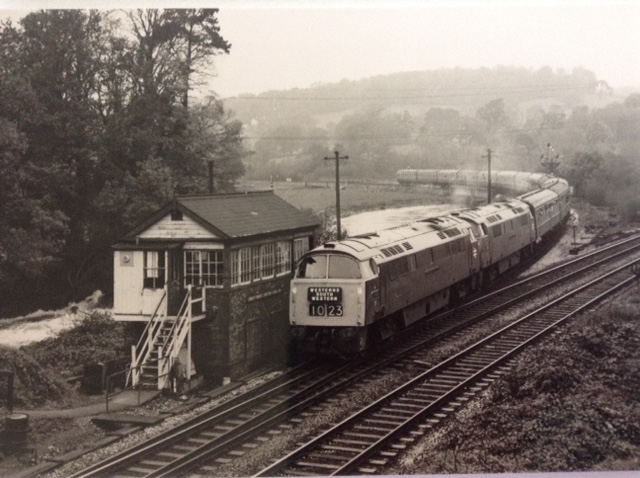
left=0, top=10, right=245, bottom=314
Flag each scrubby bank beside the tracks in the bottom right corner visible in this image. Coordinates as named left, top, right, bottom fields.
left=387, top=286, right=640, bottom=474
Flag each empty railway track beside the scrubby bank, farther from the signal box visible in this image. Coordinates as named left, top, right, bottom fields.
left=256, top=261, right=638, bottom=476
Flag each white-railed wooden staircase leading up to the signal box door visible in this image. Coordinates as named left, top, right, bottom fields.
left=127, top=286, right=205, bottom=390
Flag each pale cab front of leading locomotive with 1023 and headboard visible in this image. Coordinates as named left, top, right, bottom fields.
left=289, top=249, right=377, bottom=353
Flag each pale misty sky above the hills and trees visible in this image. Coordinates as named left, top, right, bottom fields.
left=0, top=0, right=640, bottom=97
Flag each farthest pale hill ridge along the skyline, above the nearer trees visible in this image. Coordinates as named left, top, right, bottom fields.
left=224, top=67, right=615, bottom=129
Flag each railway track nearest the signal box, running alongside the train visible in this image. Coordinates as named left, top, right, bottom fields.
left=62, top=237, right=640, bottom=477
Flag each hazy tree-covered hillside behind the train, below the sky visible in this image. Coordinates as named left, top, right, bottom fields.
left=224, top=66, right=634, bottom=186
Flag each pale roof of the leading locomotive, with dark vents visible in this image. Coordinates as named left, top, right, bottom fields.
left=309, top=216, right=469, bottom=263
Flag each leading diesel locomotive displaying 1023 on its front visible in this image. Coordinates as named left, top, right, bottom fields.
left=290, top=217, right=470, bottom=353
